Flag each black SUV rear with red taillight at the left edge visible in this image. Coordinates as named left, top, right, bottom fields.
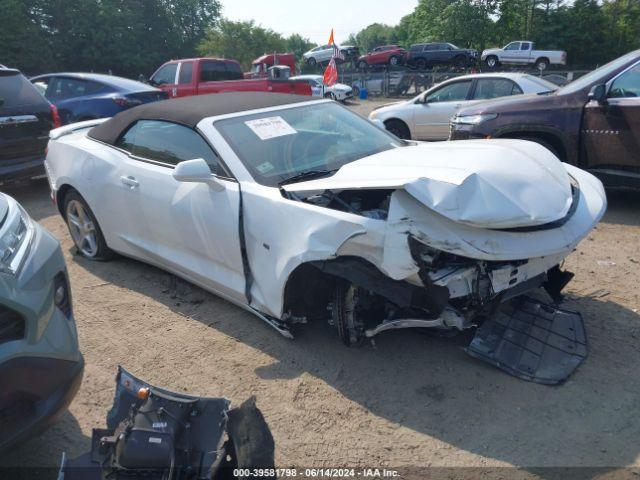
left=0, top=68, right=60, bottom=184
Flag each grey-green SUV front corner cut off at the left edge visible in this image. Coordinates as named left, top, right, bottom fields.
left=0, top=193, right=84, bottom=450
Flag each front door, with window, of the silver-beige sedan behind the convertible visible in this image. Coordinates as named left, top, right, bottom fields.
left=414, top=80, right=472, bottom=140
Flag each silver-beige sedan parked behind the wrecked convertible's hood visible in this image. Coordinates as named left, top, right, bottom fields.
left=369, top=73, right=558, bottom=140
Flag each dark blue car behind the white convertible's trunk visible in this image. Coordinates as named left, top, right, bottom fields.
left=30, top=73, right=169, bottom=125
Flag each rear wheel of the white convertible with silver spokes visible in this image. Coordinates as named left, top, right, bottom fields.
left=62, top=190, right=113, bottom=262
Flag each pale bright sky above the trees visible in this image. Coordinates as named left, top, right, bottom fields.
left=221, top=0, right=418, bottom=44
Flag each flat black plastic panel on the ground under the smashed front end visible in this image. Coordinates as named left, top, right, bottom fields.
left=467, top=298, right=588, bottom=385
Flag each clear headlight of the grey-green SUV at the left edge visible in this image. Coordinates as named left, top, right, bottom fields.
left=0, top=203, right=35, bottom=275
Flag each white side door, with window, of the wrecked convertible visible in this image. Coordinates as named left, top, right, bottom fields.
left=110, top=120, right=245, bottom=302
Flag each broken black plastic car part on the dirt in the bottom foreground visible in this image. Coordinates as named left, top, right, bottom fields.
left=58, top=367, right=275, bottom=480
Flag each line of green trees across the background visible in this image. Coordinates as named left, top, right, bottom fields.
left=0, top=0, right=640, bottom=78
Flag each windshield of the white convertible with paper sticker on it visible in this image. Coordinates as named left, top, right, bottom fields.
left=215, top=103, right=406, bottom=187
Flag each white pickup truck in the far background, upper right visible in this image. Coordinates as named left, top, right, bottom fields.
left=480, top=40, right=567, bottom=70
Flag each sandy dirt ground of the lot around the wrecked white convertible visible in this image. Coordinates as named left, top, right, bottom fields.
left=2, top=102, right=640, bottom=478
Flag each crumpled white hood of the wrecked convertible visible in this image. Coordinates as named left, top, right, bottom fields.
left=282, top=140, right=572, bottom=229
